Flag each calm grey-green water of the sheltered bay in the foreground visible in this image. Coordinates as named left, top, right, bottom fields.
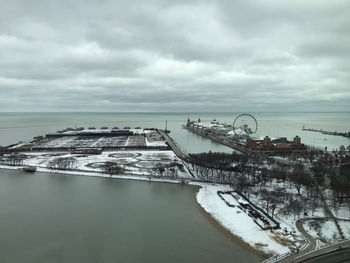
left=0, top=170, right=259, bottom=263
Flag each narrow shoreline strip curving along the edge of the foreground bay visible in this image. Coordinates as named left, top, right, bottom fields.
left=0, top=165, right=273, bottom=260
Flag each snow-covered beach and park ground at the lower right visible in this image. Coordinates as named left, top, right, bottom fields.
left=197, top=183, right=350, bottom=255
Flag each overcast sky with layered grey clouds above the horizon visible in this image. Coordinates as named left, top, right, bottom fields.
left=0, top=0, right=350, bottom=112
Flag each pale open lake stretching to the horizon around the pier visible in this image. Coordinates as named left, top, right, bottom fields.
left=0, top=113, right=350, bottom=153
